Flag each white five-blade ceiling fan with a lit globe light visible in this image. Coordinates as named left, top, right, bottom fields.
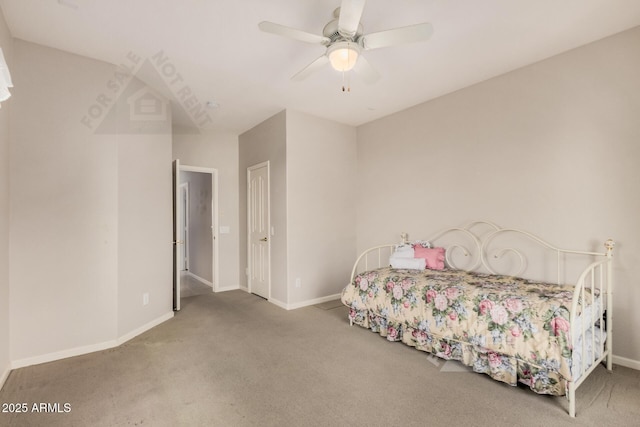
left=258, top=0, right=433, bottom=83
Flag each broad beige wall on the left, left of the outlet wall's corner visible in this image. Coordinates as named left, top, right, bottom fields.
left=10, top=40, right=118, bottom=361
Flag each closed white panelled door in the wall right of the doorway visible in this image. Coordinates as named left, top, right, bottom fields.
left=247, top=162, right=271, bottom=299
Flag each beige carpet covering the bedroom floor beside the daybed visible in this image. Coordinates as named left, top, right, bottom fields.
left=0, top=291, right=640, bottom=426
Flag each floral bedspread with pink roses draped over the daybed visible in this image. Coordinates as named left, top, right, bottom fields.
left=342, top=267, right=590, bottom=395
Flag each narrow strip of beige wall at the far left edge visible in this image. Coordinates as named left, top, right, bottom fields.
left=0, top=4, right=14, bottom=387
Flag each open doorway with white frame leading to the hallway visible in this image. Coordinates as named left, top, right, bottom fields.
left=174, top=165, right=218, bottom=310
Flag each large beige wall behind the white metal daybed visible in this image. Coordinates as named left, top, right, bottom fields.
left=357, top=28, right=640, bottom=368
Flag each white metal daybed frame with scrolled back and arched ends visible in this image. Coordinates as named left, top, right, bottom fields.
left=351, top=221, right=615, bottom=417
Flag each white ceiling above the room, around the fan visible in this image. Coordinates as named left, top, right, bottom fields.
left=0, top=0, right=640, bottom=133
